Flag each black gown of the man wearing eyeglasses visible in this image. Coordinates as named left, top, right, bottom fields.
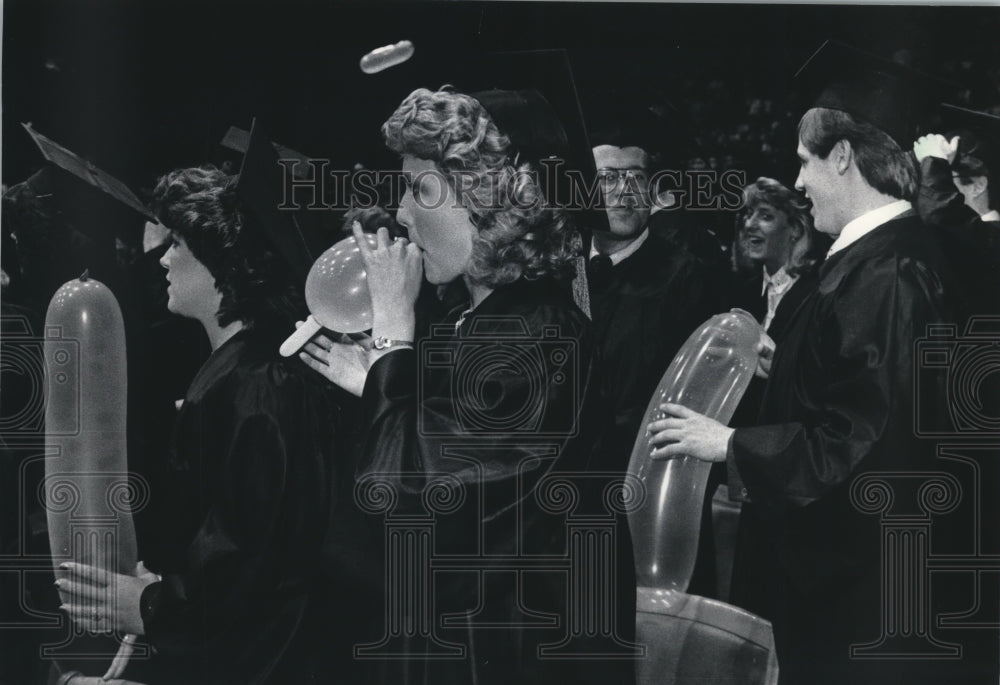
left=590, top=233, right=723, bottom=600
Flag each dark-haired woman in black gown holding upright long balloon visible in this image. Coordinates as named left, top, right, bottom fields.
left=59, top=167, right=334, bottom=685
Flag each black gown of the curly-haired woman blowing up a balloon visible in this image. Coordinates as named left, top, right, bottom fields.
left=359, top=280, right=634, bottom=685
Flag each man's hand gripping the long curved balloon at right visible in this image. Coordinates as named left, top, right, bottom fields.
left=646, top=404, right=734, bottom=461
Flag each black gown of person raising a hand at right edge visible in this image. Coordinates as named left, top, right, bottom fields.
left=917, top=157, right=1000, bottom=316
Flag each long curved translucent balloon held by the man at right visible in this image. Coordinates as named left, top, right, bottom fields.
left=628, top=310, right=761, bottom=592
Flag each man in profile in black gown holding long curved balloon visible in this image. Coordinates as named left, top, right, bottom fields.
left=651, top=43, right=978, bottom=684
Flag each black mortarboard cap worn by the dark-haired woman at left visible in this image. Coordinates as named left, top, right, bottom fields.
left=236, top=120, right=314, bottom=285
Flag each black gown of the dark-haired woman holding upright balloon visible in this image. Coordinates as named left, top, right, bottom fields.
left=126, top=331, right=335, bottom=685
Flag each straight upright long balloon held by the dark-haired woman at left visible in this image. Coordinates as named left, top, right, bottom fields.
left=44, top=274, right=138, bottom=602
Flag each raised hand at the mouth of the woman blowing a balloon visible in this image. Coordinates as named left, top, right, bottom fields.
left=352, top=222, right=423, bottom=340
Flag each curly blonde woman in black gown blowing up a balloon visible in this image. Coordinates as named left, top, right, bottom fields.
left=294, top=89, right=624, bottom=683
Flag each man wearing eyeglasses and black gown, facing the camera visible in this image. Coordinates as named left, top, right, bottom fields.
left=585, top=96, right=721, bottom=596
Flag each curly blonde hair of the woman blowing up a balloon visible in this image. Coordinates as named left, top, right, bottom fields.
left=382, top=86, right=582, bottom=287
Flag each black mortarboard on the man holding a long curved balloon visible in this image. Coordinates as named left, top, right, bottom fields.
left=795, top=41, right=954, bottom=150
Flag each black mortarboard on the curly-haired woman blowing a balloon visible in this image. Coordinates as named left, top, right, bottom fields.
left=463, top=50, right=607, bottom=232
